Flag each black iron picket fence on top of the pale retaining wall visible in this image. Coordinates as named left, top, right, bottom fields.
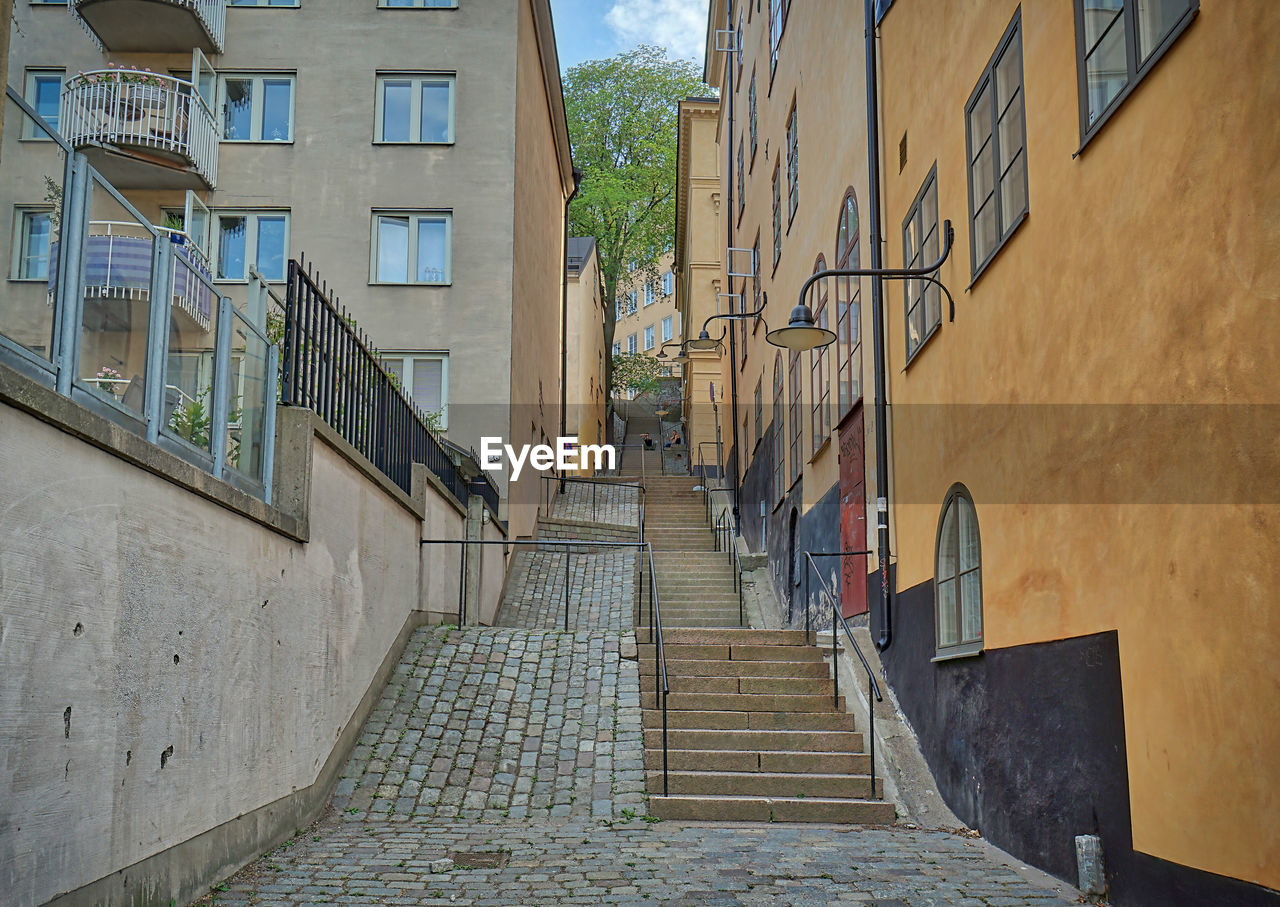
left=282, top=260, right=467, bottom=504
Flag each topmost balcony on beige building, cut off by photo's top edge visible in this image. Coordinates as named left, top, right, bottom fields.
left=68, top=0, right=227, bottom=54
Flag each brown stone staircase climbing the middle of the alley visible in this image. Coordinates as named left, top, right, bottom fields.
left=636, top=477, right=895, bottom=824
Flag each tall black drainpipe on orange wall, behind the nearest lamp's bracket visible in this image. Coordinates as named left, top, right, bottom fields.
left=865, top=0, right=893, bottom=651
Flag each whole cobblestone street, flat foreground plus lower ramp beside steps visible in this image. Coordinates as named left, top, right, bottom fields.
left=204, top=628, right=1075, bottom=907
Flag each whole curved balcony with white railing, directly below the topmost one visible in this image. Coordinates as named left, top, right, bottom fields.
left=60, top=69, right=218, bottom=189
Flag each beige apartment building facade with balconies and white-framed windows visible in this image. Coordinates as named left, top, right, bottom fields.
left=0, top=0, right=572, bottom=533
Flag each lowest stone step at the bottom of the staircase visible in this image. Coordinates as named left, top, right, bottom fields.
left=649, top=794, right=896, bottom=825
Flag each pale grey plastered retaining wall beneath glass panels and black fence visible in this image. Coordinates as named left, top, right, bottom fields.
left=0, top=391, right=481, bottom=904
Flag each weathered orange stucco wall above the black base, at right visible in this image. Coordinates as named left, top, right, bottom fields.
left=881, top=0, right=1280, bottom=888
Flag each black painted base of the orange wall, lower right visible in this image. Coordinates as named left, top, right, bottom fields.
left=870, top=582, right=1280, bottom=907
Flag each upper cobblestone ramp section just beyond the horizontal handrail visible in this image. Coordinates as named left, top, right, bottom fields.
left=495, top=546, right=636, bottom=633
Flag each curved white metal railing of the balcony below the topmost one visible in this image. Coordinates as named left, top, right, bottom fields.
left=60, top=69, right=218, bottom=188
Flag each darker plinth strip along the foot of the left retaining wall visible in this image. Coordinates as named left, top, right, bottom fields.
left=48, top=611, right=428, bottom=907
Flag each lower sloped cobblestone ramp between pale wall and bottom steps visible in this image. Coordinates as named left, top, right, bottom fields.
left=333, top=627, right=644, bottom=821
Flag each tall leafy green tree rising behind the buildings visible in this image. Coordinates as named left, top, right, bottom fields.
left=564, top=45, right=712, bottom=414
